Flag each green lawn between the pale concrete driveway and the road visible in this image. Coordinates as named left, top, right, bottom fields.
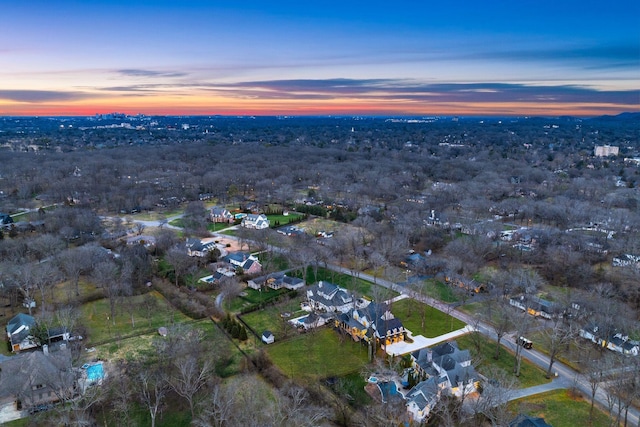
left=391, top=298, right=465, bottom=338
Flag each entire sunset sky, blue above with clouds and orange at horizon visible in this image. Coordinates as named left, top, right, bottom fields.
left=0, top=0, right=640, bottom=116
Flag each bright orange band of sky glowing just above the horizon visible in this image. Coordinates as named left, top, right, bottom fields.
left=0, top=96, right=640, bottom=117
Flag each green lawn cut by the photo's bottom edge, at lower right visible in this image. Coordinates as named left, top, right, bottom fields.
left=509, top=390, right=611, bottom=427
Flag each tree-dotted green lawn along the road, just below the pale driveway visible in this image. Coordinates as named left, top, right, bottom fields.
left=456, top=334, right=551, bottom=388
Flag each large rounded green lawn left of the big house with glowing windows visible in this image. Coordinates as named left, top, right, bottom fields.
left=267, top=328, right=368, bottom=381
